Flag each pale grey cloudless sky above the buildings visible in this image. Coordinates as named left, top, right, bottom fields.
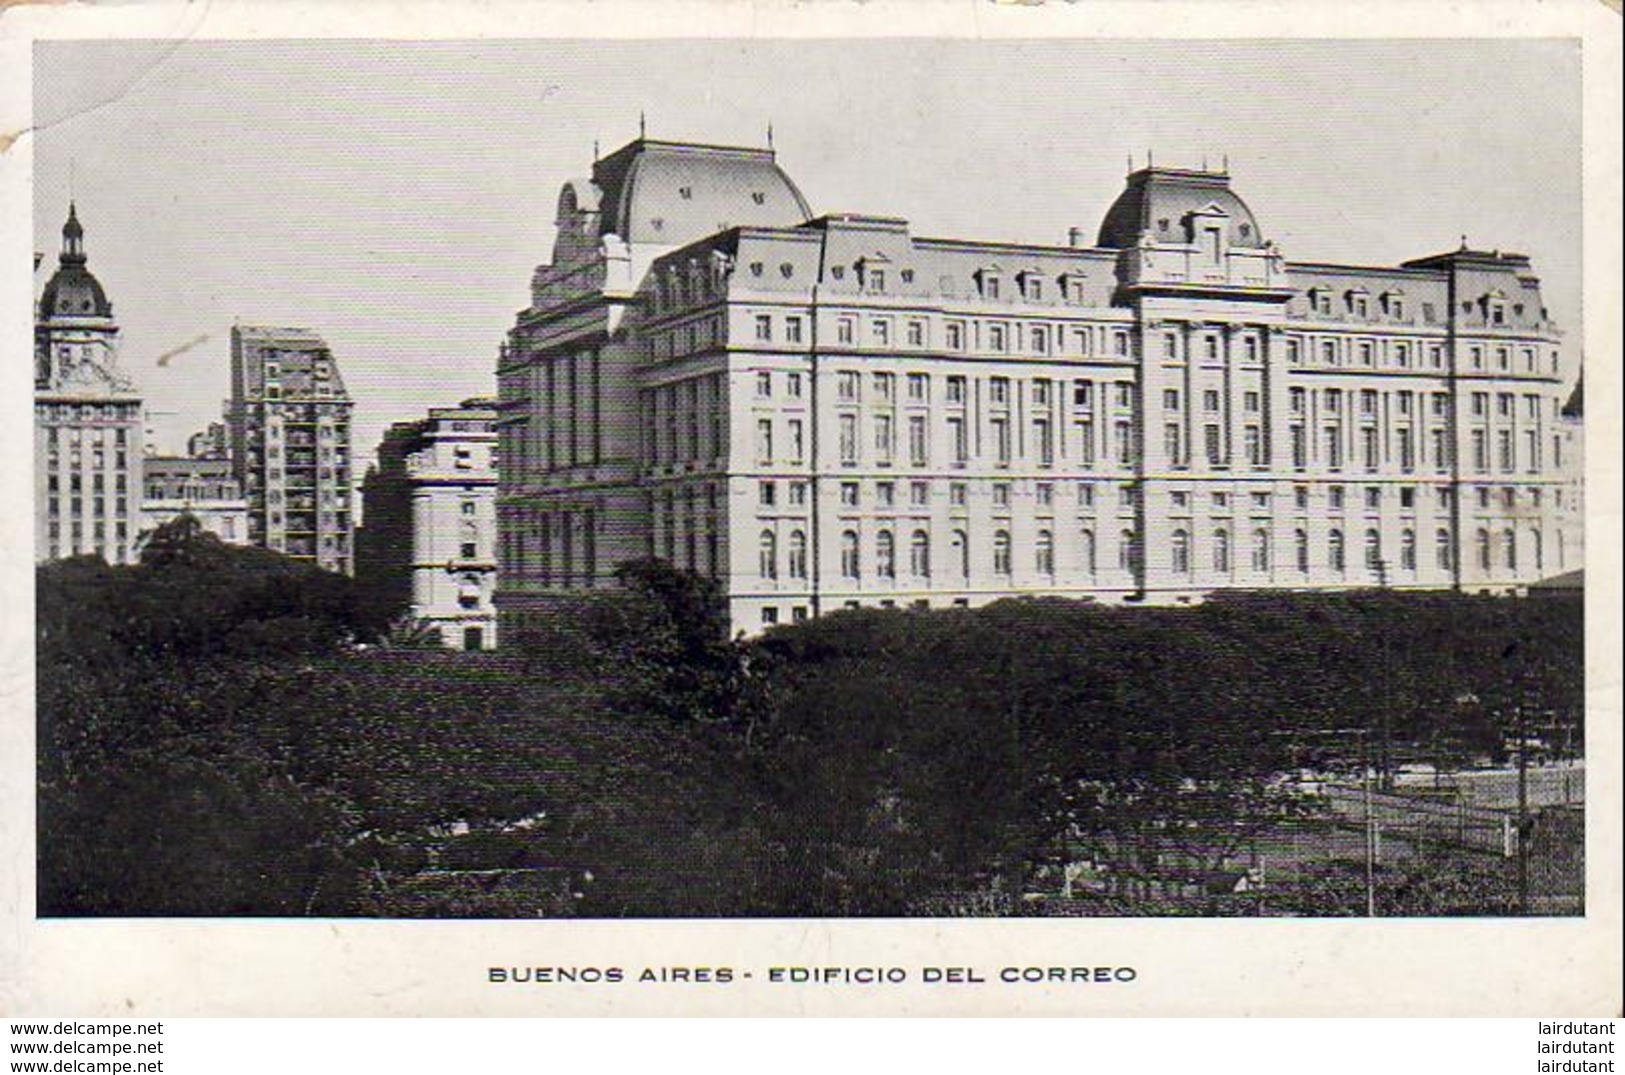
left=34, top=39, right=1581, bottom=467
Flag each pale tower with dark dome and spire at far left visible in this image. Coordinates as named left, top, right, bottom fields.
left=34, top=206, right=143, bottom=563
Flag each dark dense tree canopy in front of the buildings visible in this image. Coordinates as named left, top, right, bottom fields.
left=39, top=528, right=1581, bottom=916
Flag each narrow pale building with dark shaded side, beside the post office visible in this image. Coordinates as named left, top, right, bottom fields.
left=356, top=399, right=497, bottom=650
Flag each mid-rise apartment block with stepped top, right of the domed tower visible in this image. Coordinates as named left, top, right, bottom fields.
left=226, top=325, right=354, bottom=575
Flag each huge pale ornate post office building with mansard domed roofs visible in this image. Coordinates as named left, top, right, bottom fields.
left=497, top=140, right=1580, bottom=632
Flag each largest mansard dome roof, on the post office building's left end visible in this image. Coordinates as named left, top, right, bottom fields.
left=593, top=138, right=813, bottom=245
